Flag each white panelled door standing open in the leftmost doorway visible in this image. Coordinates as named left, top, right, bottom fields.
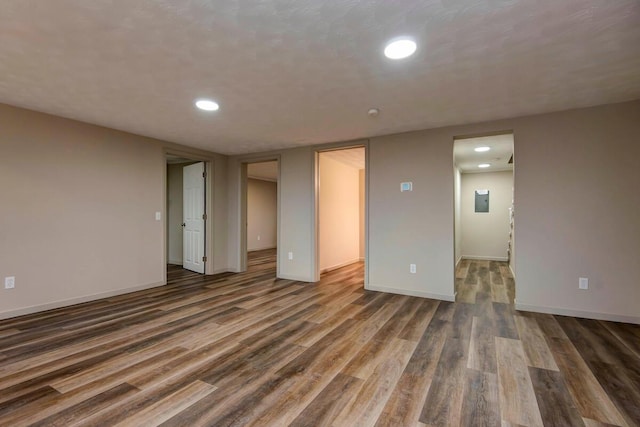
left=182, top=162, right=205, bottom=273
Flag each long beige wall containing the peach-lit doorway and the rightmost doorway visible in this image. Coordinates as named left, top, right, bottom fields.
left=222, top=101, right=640, bottom=322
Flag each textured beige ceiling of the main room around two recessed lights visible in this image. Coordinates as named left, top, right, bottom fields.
left=0, top=0, right=640, bottom=154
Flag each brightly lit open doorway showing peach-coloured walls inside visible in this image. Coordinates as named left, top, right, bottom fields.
left=316, top=147, right=366, bottom=284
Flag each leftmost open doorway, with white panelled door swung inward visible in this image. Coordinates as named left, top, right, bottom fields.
left=166, top=154, right=207, bottom=274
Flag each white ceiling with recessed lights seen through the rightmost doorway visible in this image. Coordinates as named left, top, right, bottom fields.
left=453, top=134, right=513, bottom=173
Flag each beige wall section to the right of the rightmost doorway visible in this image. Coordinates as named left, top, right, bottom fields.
left=515, top=101, right=640, bottom=322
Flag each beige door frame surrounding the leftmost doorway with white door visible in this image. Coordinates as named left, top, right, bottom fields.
left=162, top=147, right=215, bottom=284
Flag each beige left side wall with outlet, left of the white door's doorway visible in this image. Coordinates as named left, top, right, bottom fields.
left=0, top=105, right=166, bottom=317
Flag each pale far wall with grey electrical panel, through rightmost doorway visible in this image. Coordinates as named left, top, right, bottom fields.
left=460, top=171, right=513, bottom=261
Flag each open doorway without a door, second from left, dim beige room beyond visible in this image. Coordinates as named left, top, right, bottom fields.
left=245, top=160, right=279, bottom=275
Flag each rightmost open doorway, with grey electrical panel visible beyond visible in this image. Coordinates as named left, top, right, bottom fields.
left=453, top=133, right=515, bottom=304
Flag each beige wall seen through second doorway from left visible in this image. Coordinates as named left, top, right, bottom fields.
left=247, top=178, right=278, bottom=251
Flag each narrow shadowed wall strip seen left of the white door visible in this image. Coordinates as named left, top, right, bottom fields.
left=167, top=164, right=183, bottom=265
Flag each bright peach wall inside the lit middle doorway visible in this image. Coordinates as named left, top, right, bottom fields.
left=318, top=153, right=361, bottom=272
